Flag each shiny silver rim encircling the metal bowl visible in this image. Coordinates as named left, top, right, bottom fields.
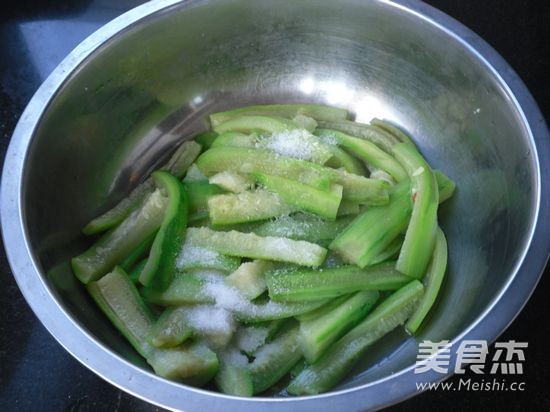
left=0, top=0, right=550, bottom=410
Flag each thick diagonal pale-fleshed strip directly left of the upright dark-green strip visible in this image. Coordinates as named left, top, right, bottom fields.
left=71, top=190, right=168, bottom=283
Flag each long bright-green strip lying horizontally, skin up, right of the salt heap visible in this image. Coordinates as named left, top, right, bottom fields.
left=265, top=262, right=410, bottom=302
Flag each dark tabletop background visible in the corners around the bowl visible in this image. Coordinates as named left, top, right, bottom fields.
left=0, top=0, right=550, bottom=412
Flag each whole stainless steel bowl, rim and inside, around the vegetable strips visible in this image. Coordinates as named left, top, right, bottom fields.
left=1, top=0, right=550, bottom=411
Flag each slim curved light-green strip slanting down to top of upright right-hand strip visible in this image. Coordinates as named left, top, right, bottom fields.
left=316, top=129, right=407, bottom=182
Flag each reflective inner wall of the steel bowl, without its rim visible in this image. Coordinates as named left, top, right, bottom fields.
left=23, top=0, right=537, bottom=396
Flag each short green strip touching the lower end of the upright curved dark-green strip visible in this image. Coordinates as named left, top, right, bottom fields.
left=141, top=273, right=214, bottom=306
